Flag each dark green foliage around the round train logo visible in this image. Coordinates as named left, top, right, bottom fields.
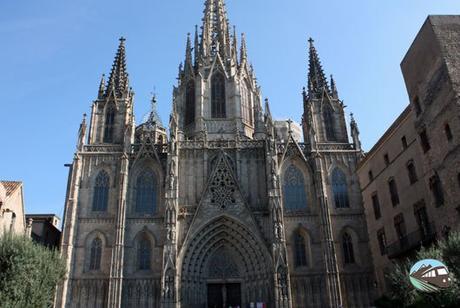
left=382, top=233, right=460, bottom=308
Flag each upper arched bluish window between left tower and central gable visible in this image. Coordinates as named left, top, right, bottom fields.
left=136, top=171, right=157, bottom=214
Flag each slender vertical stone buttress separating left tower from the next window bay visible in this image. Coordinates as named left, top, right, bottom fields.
left=108, top=153, right=129, bottom=307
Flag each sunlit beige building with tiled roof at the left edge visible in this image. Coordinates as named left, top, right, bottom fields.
left=0, top=181, right=26, bottom=236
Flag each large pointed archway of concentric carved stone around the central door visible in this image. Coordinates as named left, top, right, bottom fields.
left=179, top=216, right=273, bottom=307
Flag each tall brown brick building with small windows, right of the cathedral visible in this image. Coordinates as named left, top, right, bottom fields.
left=357, top=16, right=460, bottom=295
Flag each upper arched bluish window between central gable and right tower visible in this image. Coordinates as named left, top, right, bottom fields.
left=283, top=165, right=307, bottom=211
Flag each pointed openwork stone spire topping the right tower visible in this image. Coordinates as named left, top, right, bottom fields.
left=308, top=38, right=330, bottom=98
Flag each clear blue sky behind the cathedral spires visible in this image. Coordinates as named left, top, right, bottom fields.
left=0, top=0, right=460, bottom=217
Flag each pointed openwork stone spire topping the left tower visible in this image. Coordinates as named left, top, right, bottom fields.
left=106, top=37, right=129, bottom=97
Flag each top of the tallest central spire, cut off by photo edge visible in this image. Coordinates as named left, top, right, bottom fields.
left=201, top=0, right=230, bottom=60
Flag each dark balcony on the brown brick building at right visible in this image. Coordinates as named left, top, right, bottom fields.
left=386, top=223, right=436, bottom=259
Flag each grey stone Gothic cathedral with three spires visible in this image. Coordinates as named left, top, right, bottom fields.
left=55, top=0, right=375, bottom=308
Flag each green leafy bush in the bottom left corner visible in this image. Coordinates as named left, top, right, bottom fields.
left=0, top=234, right=65, bottom=308
